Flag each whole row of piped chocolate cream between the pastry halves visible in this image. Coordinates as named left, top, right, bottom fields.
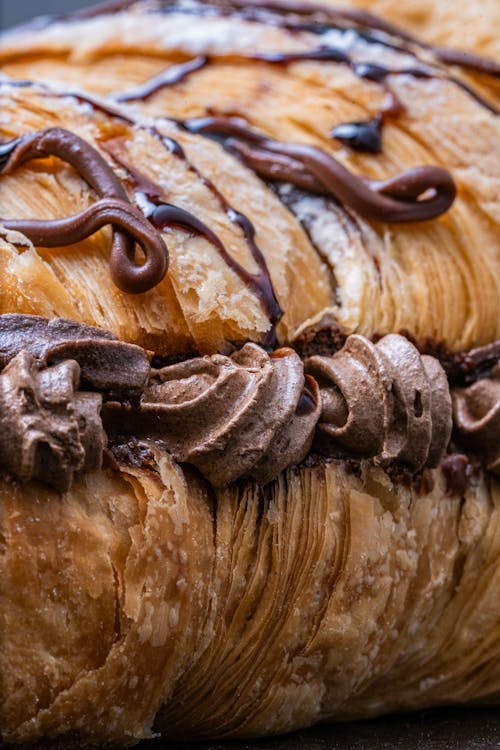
left=0, top=314, right=500, bottom=491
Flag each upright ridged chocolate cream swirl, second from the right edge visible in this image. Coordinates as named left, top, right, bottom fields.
left=305, top=334, right=451, bottom=471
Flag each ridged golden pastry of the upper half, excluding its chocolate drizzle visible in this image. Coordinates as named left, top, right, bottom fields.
left=2, top=3, right=500, bottom=352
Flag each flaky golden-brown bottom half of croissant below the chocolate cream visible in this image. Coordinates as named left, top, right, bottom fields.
left=0, top=452, right=500, bottom=747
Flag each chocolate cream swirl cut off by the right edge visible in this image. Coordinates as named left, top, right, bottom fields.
left=452, top=362, right=500, bottom=476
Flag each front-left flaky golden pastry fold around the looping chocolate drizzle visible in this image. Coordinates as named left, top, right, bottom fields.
left=0, top=89, right=333, bottom=354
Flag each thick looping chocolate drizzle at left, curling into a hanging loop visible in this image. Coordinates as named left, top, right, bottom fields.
left=0, top=128, right=168, bottom=294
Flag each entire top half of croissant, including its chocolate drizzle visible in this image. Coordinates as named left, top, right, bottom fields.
left=0, top=0, right=500, bottom=355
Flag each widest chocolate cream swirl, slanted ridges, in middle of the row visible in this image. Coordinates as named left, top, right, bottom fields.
left=104, top=344, right=321, bottom=486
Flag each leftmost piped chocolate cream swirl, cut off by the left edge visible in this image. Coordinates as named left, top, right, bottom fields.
left=0, top=350, right=105, bottom=492
